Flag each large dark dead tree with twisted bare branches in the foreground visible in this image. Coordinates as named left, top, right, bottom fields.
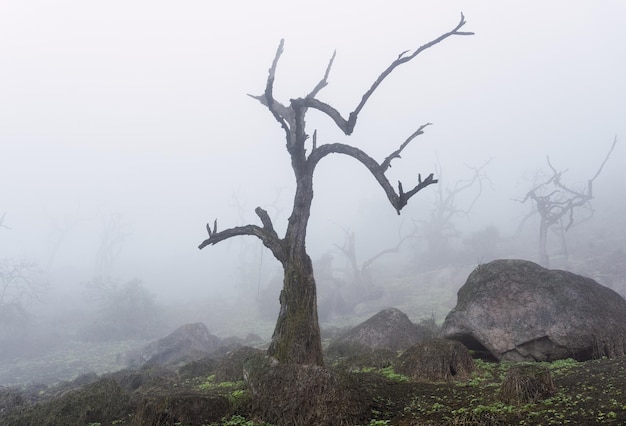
left=199, top=14, right=472, bottom=365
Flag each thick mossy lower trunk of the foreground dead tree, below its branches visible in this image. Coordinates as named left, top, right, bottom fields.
left=268, top=253, right=324, bottom=365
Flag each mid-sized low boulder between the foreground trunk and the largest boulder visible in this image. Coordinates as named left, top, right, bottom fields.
left=327, top=308, right=429, bottom=357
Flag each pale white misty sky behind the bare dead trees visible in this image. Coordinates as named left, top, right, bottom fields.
left=0, top=0, right=626, bottom=302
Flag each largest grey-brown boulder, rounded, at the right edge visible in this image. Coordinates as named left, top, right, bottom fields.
left=442, top=259, right=626, bottom=361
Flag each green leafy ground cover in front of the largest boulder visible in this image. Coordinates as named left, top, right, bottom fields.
left=360, top=357, right=626, bottom=425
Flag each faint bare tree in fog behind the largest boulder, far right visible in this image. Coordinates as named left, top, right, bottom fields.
left=521, top=137, right=617, bottom=267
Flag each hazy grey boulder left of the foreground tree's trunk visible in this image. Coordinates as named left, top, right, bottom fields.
left=141, top=322, right=220, bottom=366
